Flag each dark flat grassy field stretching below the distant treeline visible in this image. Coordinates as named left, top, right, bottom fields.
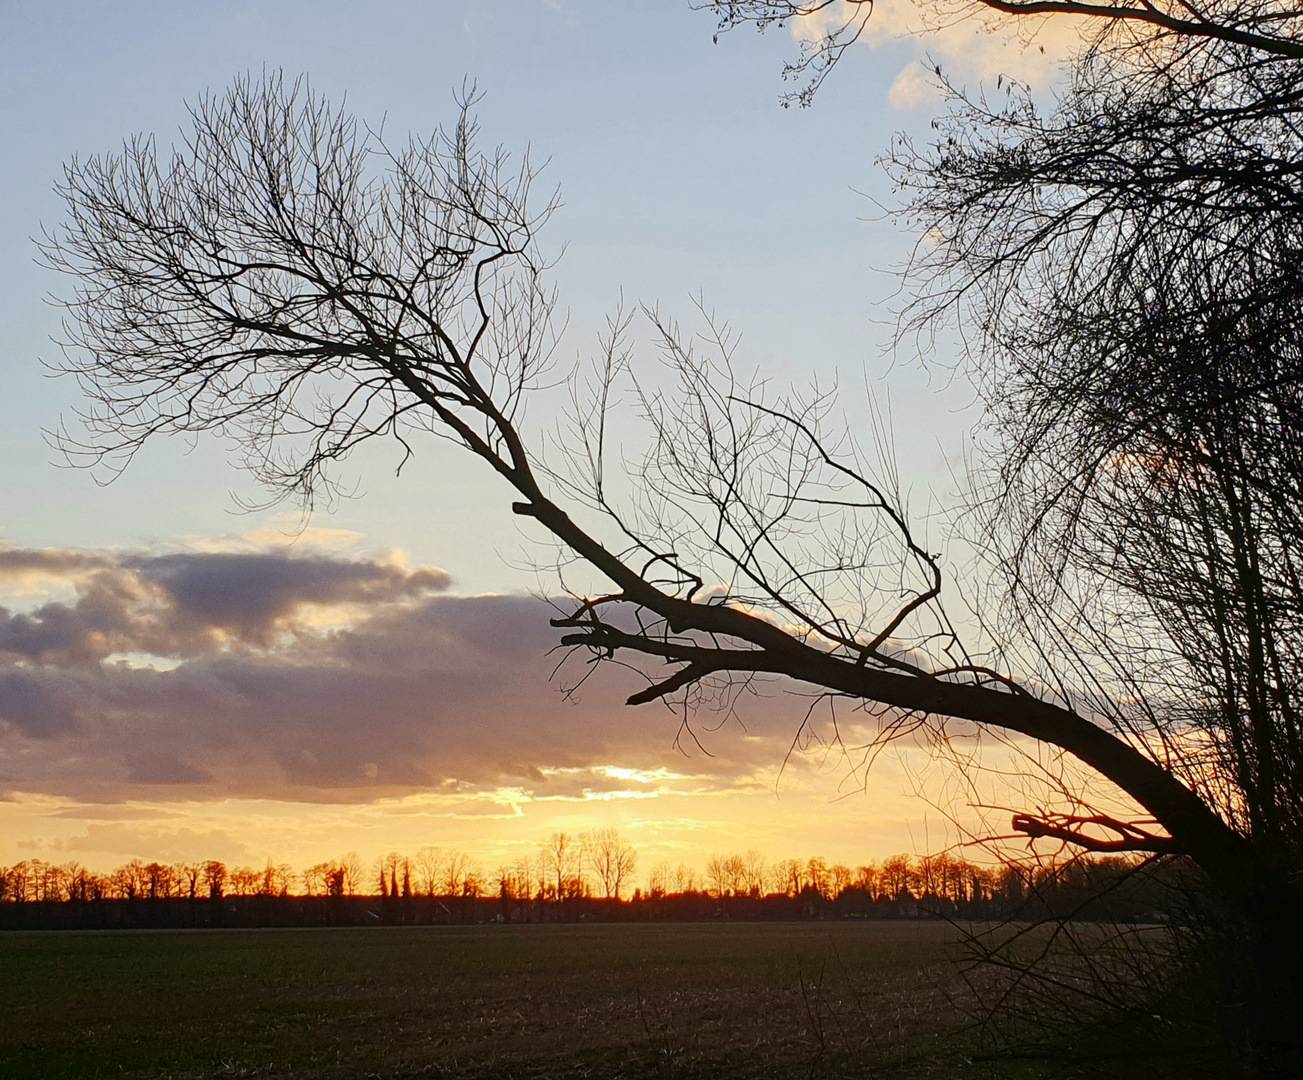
left=0, top=922, right=995, bottom=1080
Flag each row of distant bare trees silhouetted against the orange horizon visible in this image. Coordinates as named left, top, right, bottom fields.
left=0, top=829, right=1183, bottom=918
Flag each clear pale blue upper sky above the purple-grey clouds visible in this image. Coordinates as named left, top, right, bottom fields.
left=0, top=0, right=962, bottom=581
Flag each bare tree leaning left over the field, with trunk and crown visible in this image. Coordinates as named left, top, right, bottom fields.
left=44, top=67, right=1299, bottom=1063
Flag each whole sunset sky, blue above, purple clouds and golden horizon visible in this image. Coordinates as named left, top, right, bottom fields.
left=0, top=0, right=1070, bottom=869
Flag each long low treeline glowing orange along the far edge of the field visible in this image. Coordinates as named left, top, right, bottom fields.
left=0, top=829, right=1171, bottom=929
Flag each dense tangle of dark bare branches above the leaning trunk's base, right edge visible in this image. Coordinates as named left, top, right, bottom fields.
left=894, top=2, right=1303, bottom=857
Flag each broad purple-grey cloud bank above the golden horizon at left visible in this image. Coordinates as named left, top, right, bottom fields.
left=0, top=550, right=805, bottom=813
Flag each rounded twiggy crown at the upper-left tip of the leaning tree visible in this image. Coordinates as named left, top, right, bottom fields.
left=43, top=74, right=552, bottom=510
